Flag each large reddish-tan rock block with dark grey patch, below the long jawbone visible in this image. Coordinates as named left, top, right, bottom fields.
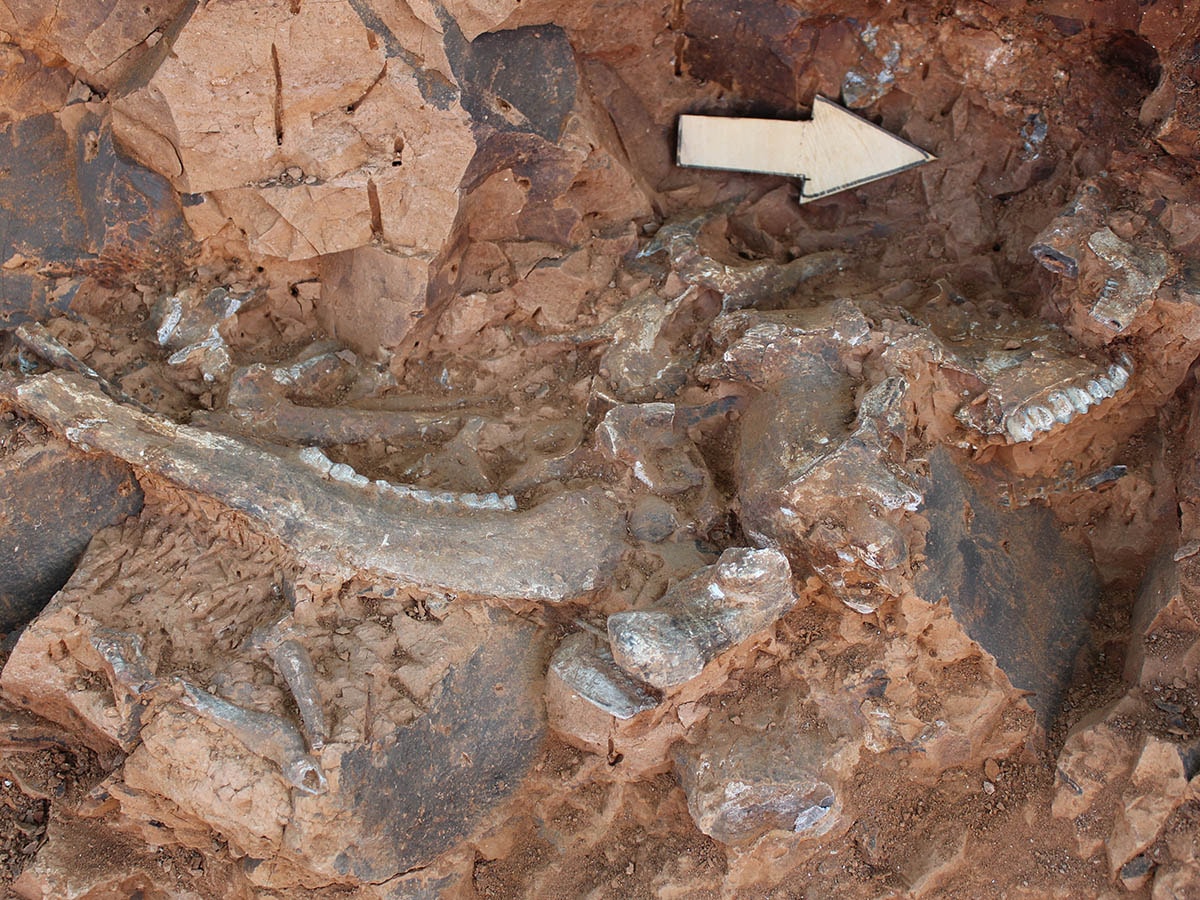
left=0, top=500, right=545, bottom=889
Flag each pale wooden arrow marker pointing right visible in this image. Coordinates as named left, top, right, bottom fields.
left=677, top=96, right=937, bottom=203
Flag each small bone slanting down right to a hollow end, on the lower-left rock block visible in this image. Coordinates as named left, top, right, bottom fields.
left=178, top=678, right=329, bottom=794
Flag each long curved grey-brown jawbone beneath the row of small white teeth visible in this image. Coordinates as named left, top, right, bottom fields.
left=0, top=373, right=624, bottom=602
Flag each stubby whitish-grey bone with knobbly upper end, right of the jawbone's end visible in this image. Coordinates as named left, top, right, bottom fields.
left=608, top=547, right=796, bottom=690
